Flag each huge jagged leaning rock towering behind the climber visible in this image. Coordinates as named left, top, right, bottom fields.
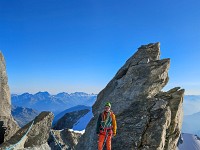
left=76, top=43, right=184, bottom=150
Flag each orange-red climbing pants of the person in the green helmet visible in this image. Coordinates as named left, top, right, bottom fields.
left=98, top=131, right=112, bottom=150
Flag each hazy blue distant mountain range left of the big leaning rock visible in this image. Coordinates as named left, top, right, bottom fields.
left=11, top=92, right=97, bottom=115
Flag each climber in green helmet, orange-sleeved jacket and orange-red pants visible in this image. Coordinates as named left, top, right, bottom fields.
left=96, top=102, right=117, bottom=150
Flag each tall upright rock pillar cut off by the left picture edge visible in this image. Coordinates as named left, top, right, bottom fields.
left=0, top=52, right=19, bottom=141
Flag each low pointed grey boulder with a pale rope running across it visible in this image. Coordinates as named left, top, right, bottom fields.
left=0, top=112, right=53, bottom=149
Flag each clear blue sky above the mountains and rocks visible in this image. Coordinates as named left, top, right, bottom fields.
left=0, top=0, right=200, bottom=95
